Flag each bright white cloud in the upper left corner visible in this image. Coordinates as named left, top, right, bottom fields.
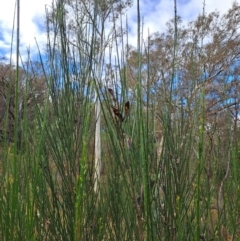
left=0, top=0, right=51, bottom=60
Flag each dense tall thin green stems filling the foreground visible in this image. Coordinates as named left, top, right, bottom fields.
left=0, top=0, right=240, bottom=241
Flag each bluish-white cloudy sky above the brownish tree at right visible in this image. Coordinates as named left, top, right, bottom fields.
left=126, top=0, right=240, bottom=46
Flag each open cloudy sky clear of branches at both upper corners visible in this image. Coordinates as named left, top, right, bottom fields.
left=0, top=0, right=240, bottom=60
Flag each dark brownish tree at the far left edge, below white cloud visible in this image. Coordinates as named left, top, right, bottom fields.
left=0, top=61, right=47, bottom=146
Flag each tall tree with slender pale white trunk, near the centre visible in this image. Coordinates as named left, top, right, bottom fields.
left=51, top=0, right=132, bottom=197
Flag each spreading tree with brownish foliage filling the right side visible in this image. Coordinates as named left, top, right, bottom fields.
left=124, top=2, right=240, bottom=238
